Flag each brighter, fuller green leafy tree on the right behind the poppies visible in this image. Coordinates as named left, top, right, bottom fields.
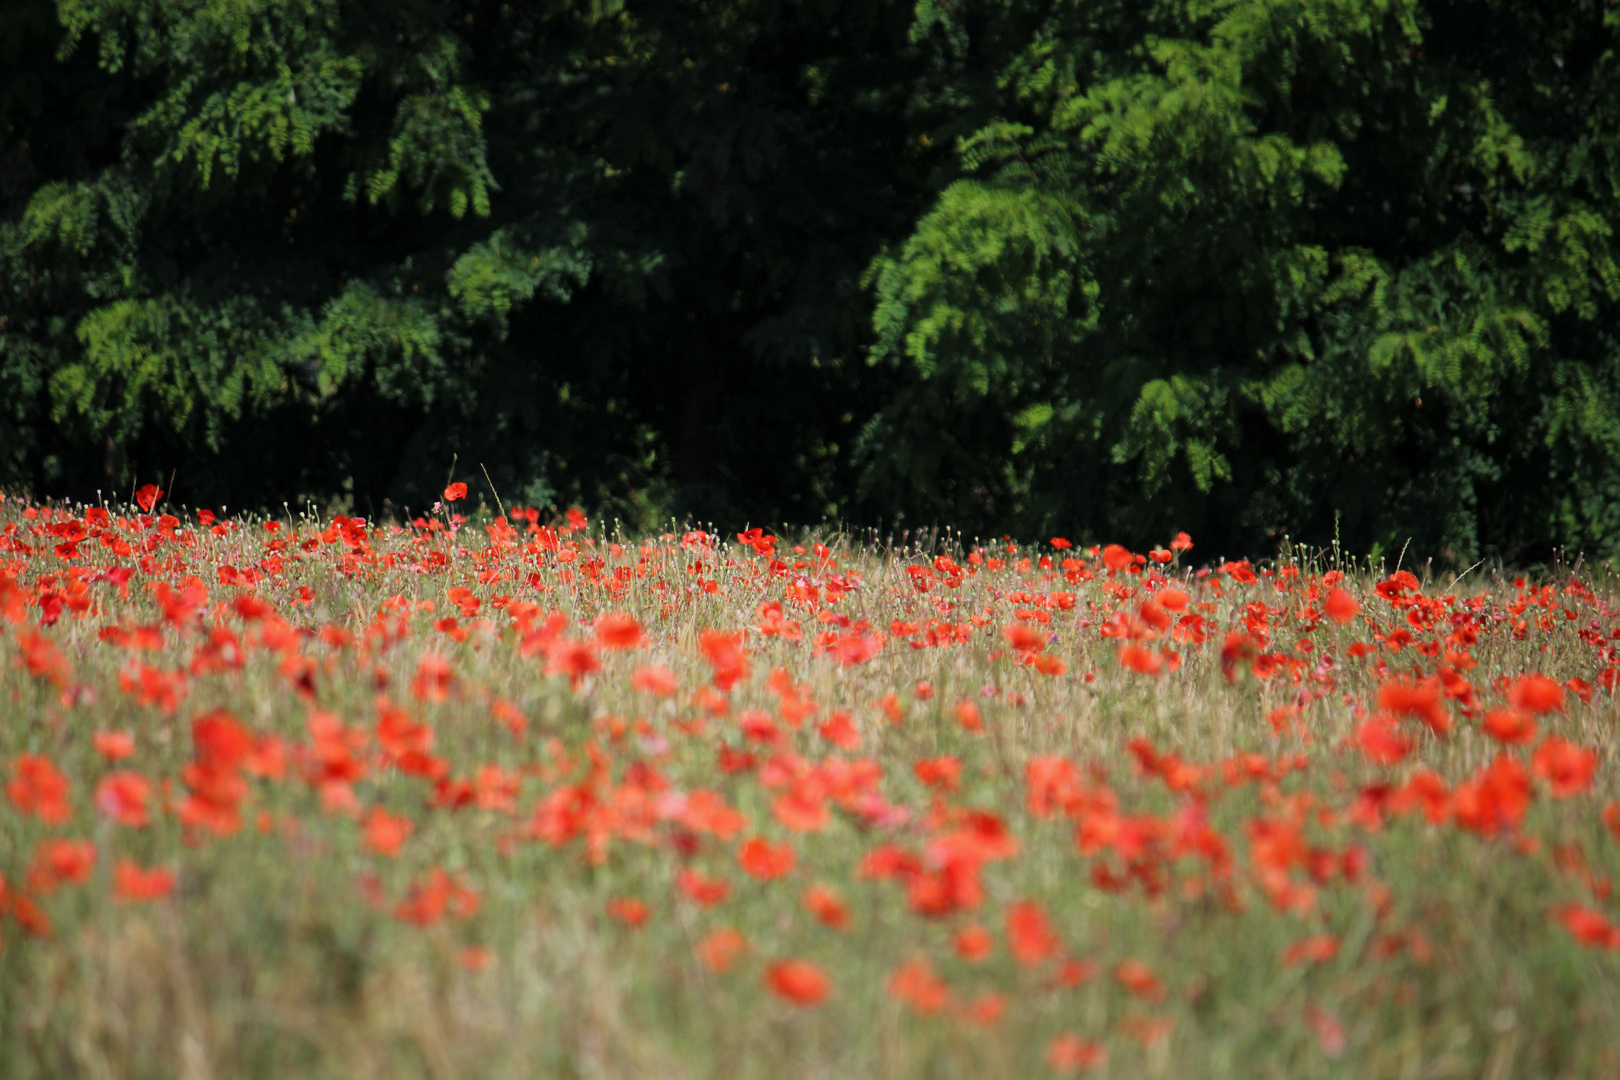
left=862, top=0, right=1620, bottom=559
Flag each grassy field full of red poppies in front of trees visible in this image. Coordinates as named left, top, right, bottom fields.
left=0, top=484, right=1620, bottom=1078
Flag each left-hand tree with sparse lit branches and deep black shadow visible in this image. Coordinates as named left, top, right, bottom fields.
left=0, top=0, right=944, bottom=520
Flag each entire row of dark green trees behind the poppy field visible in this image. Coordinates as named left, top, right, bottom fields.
left=0, top=0, right=1620, bottom=562
